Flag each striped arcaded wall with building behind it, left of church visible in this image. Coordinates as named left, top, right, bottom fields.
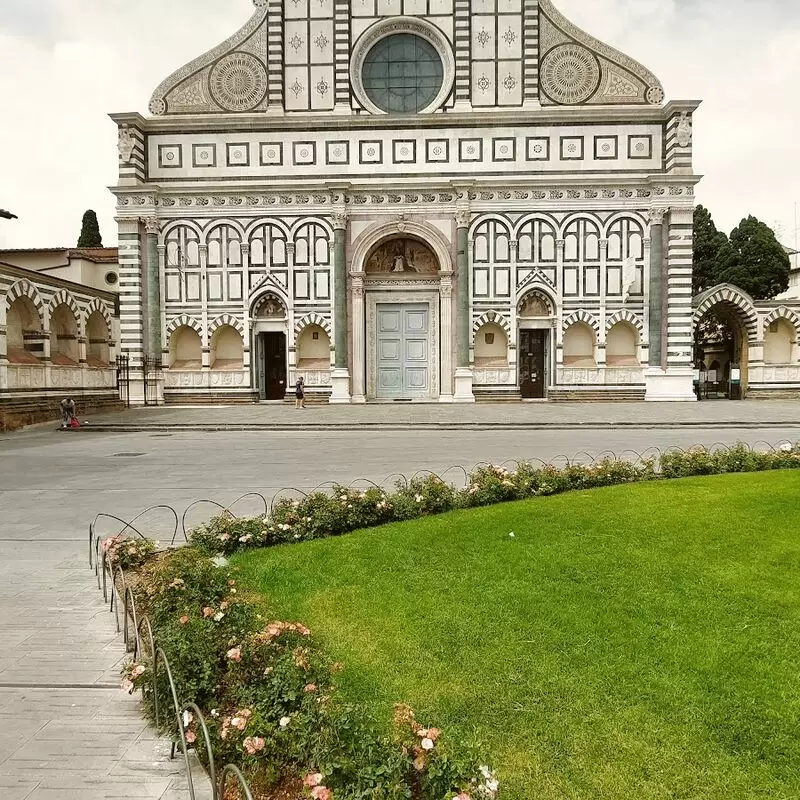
left=0, top=248, right=119, bottom=430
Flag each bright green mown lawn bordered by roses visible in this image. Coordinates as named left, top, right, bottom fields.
left=231, top=472, right=800, bottom=800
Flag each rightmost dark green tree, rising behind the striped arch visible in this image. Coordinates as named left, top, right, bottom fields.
left=716, top=216, right=792, bottom=300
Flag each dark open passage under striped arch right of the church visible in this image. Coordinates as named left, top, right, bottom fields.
left=694, top=300, right=750, bottom=400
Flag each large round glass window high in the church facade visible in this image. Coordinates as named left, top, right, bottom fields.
left=362, top=33, right=444, bottom=114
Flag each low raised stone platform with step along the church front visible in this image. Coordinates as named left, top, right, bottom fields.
left=70, top=400, right=800, bottom=432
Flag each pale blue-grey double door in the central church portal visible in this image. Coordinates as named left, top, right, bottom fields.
left=377, top=304, right=431, bottom=400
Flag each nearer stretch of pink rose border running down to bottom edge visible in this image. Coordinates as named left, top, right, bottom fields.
left=117, top=546, right=497, bottom=800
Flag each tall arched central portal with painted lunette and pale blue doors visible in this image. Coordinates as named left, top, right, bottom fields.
left=351, top=221, right=453, bottom=402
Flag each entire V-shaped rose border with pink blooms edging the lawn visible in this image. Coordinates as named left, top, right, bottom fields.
left=112, top=445, right=800, bottom=800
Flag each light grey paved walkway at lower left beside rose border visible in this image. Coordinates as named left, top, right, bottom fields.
left=0, top=506, right=210, bottom=800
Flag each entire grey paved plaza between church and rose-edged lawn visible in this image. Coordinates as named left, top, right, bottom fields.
left=0, top=410, right=800, bottom=800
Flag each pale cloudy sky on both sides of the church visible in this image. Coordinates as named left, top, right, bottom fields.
left=0, top=0, right=800, bottom=252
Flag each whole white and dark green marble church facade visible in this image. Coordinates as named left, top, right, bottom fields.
left=113, top=0, right=699, bottom=403
